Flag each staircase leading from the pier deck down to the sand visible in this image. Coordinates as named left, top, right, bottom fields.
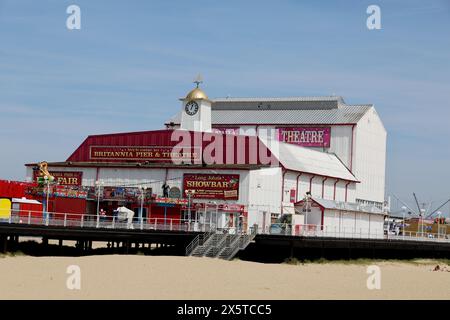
left=186, top=227, right=258, bottom=260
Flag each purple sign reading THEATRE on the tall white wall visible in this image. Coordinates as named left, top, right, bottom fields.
left=277, top=127, right=330, bottom=148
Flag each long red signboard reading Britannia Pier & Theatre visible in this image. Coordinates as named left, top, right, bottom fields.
left=89, top=146, right=201, bottom=161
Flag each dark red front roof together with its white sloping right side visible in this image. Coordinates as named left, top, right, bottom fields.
left=27, top=130, right=357, bottom=182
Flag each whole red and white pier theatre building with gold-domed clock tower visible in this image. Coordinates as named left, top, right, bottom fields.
left=27, top=88, right=386, bottom=236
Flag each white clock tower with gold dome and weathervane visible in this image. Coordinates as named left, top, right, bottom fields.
left=180, top=80, right=211, bottom=132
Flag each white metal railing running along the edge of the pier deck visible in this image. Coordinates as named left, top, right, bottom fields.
left=0, top=210, right=450, bottom=245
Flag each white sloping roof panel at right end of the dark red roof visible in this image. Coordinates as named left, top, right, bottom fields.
left=260, top=138, right=358, bottom=182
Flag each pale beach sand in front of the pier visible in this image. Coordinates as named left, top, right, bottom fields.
left=0, top=255, right=450, bottom=299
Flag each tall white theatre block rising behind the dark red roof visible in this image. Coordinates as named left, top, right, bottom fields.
left=166, top=96, right=386, bottom=209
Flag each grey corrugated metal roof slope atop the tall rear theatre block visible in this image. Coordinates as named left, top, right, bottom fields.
left=167, top=105, right=373, bottom=125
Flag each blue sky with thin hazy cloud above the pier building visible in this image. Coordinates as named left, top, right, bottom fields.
left=0, top=0, right=450, bottom=214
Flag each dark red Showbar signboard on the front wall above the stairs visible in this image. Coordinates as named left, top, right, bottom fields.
left=183, top=174, right=239, bottom=200
